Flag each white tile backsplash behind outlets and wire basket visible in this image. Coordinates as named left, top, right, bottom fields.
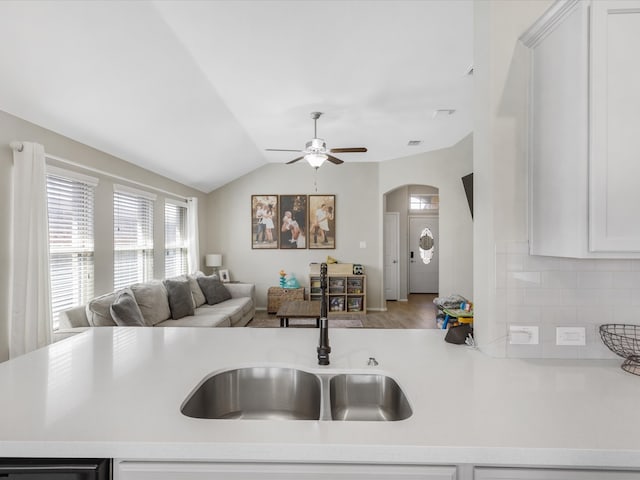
left=495, top=242, right=640, bottom=358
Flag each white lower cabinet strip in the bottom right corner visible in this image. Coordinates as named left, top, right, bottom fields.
left=473, top=468, right=640, bottom=480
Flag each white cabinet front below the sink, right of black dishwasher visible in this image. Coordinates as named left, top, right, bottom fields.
left=114, top=461, right=457, bottom=480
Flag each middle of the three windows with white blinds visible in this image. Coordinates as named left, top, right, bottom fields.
left=113, top=185, right=155, bottom=289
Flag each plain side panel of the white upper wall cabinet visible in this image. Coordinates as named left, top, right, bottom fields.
left=523, top=2, right=589, bottom=257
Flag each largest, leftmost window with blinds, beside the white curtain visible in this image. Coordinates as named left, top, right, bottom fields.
left=47, top=167, right=98, bottom=330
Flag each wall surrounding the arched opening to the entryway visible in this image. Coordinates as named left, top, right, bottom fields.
left=380, top=135, right=475, bottom=304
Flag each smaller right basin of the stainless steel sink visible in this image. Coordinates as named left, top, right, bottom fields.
left=329, top=374, right=413, bottom=421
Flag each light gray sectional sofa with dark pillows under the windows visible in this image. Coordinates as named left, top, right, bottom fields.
left=55, top=272, right=255, bottom=339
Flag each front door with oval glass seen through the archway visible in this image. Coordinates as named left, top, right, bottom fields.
left=409, top=217, right=440, bottom=293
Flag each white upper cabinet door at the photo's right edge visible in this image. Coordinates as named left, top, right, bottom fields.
left=589, top=0, right=640, bottom=252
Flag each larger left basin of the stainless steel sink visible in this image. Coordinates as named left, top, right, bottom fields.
left=181, top=367, right=322, bottom=420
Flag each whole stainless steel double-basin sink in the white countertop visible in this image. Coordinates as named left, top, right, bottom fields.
left=181, top=367, right=413, bottom=421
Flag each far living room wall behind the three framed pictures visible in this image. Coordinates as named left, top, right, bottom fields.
left=203, top=162, right=382, bottom=309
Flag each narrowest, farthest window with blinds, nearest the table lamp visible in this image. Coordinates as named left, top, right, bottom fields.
left=164, top=199, right=189, bottom=278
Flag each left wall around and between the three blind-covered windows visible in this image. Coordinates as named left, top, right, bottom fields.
left=0, top=111, right=208, bottom=361
